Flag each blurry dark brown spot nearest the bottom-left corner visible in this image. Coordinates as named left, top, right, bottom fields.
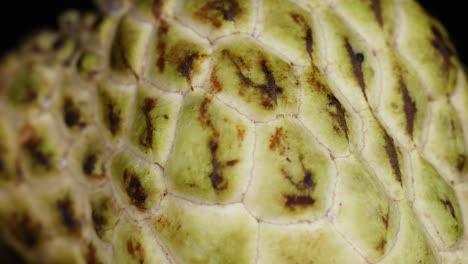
left=7, top=212, right=43, bottom=249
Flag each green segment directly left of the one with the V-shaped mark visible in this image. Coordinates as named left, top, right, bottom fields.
left=148, top=20, right=211, bottom=93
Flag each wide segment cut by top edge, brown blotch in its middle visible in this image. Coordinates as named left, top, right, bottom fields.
left=176, top=0, right=256, bottom=40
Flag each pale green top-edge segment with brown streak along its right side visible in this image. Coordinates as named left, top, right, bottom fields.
left=259, top=0, right=318, bottom=65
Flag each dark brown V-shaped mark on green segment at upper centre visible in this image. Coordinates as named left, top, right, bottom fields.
left=225, top=53, right=283, bottom=109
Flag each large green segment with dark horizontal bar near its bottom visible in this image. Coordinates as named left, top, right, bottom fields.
left=244, top=118, right=334, bottom=222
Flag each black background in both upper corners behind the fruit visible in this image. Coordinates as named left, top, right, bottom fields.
left=0, top=0, right=468, bottom=64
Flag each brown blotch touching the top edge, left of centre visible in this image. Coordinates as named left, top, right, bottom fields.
left=193, top=0, right=240, bottom=28
